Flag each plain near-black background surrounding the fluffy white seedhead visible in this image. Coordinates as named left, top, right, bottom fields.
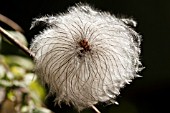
left=0, top=0, right=170, bottom=113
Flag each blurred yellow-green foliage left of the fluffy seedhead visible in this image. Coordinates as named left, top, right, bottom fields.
left=0, top=31, right=51, bottom=113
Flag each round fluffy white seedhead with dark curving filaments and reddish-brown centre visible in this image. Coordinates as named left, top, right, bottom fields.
left=30, top=5, right=141, bottom=110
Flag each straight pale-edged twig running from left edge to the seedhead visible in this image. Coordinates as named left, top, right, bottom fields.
left=0, top=27, right=34, bottom=58
